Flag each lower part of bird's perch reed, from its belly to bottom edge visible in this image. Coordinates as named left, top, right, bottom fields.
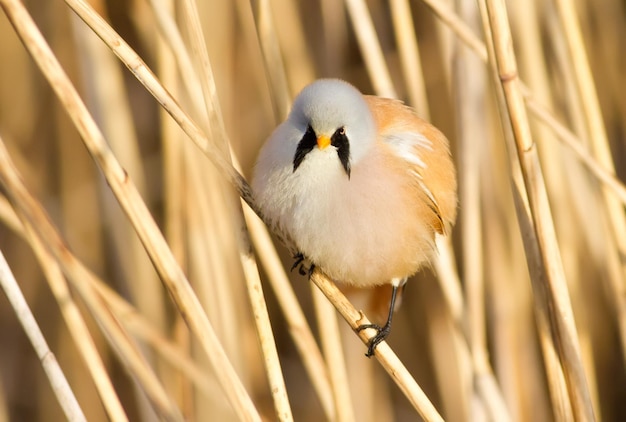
left=311, top=270, right=443, bottom=421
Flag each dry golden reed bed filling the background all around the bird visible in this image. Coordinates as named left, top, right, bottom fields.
left=0, top=0, right=626, bottom=421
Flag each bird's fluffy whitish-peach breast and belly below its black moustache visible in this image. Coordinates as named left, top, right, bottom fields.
left=253, top=134, right=433, bottom=287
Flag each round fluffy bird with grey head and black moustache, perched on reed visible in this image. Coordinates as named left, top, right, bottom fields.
left=252, top=79, right=457, bottom=357
